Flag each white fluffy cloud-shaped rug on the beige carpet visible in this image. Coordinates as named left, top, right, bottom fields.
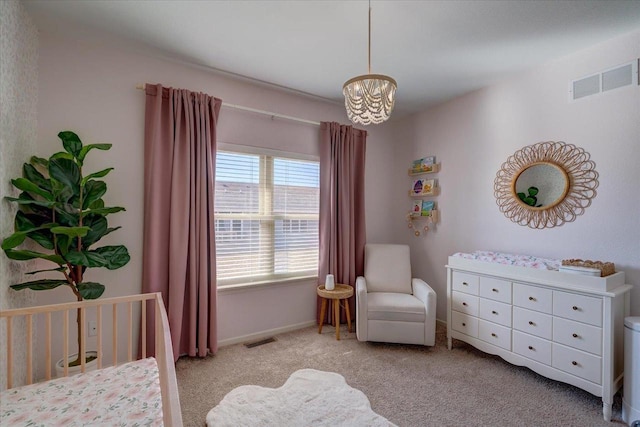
left=207, top=369, right=395, bottom=427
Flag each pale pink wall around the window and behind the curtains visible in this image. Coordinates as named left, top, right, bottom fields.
left=37, top=29, right=393, bottom=358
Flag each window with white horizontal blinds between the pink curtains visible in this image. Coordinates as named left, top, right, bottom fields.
left=215, top=151, right=320, bottom=286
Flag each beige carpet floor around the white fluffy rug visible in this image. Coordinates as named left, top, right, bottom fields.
left=176, top=325, right=624, bottom=427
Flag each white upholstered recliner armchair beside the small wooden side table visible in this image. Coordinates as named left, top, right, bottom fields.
left=356, top=244, right=436, bottom=345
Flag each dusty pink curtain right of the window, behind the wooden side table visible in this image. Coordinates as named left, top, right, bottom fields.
left=317, top=122, right=367, bottom=324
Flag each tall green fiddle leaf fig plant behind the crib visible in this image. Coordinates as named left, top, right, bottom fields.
left=2, top=131, right=130, bottom=366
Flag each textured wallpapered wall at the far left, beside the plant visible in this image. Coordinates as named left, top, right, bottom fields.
left=0, top=0, right=38, bottom=390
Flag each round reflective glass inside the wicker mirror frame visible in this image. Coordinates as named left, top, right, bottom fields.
left=514, top=163, right=569, bottom=209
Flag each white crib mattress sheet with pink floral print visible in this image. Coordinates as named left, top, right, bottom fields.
left=0, top=357, right=162, bottom=426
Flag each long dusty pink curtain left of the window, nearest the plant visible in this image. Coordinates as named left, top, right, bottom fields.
left=142, top=84, right=222, bottom=360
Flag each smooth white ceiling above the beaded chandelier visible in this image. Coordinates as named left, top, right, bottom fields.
left=23, top=0, right=640, bottom=115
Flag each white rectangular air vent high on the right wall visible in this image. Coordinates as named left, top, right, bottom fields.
left=569, top=59, right=640, bottom=101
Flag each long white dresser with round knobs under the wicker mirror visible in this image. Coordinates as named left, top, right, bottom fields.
left=447, top=257, right=631, bottom=421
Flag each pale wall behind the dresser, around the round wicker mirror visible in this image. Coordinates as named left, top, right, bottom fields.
left=394, top=32, right=640, bottom=319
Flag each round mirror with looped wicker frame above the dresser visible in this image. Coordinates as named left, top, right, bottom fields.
left=494, top=141, right=598, bottom=228
